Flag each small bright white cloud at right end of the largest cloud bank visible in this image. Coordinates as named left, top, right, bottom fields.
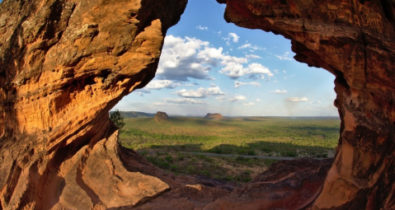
left=220, top=62, right=273, bottom=79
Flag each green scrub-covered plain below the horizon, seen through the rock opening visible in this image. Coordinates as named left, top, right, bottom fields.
left=120, top=117, right=340, bottom=182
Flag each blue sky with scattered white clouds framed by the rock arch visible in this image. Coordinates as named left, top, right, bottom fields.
left=114, top=0, right=338, bottom=116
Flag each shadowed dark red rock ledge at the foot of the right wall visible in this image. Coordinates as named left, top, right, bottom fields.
left=204, top=159, right=332, bottom=210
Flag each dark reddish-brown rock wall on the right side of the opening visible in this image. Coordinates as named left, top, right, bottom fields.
left=218, top=0, right=395, bottom=209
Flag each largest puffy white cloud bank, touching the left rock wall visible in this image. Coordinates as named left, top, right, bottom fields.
left=157, top=35, right=273, bottom=81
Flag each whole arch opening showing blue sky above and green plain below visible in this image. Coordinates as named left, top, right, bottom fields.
left=113, top=0, right=340, bottom=183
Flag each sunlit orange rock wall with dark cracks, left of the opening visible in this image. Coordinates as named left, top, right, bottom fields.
left=0, top=0, right=186, bottom=209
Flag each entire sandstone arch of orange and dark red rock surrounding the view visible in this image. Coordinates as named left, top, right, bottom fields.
left=0, top=0, right=395, bottom=209
